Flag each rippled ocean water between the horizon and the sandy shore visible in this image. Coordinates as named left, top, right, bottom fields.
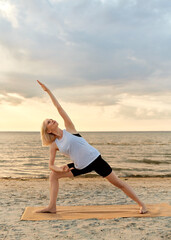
left=0, top=132, right=171, bottom=178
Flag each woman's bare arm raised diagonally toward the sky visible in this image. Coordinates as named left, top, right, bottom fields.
left=37, top=80, right=77, bottom=133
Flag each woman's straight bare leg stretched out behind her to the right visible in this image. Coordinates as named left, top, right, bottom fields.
left=106, top=172, right=147, bottom=213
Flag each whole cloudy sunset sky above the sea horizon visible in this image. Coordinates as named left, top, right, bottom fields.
left=0, top=0, right=171, bottom=131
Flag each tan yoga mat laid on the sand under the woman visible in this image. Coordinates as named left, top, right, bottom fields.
left=21, top=203, right=171, bottom=221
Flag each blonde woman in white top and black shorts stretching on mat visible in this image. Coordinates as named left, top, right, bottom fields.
left=37, top=80, right=147, bottom=213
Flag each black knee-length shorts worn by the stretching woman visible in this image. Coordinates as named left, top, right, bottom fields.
left=68, top=155, right=112, bottom=177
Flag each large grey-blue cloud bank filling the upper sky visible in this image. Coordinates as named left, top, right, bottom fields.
left=0, top=0, right=171, bottom=105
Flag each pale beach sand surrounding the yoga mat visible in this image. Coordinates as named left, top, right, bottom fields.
left=0, top=177, right=171, bottom=240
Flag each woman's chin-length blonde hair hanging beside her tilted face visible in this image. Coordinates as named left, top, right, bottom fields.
left=41, top=120, right=56, bottom=146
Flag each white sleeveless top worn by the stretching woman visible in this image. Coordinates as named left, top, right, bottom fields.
left=55, top=129, right=100, bottom=169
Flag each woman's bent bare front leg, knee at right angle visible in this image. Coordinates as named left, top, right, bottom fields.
left=36, top=171, right=73, bottom=213
